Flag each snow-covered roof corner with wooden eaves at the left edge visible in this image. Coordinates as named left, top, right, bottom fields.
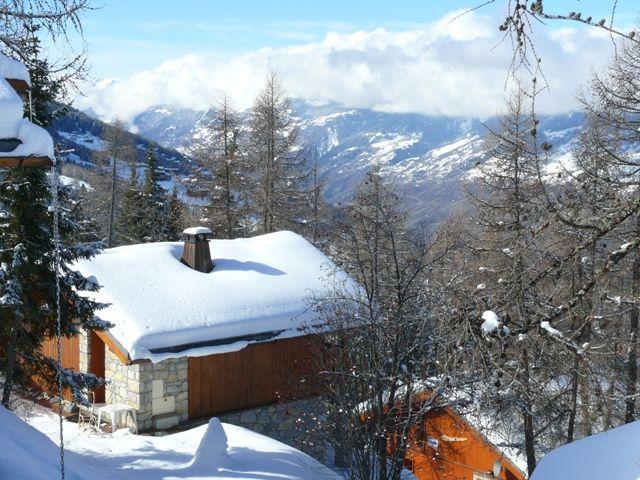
left=0, top=54, right=53, bottom=165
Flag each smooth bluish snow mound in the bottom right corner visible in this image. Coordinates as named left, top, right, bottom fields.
left=531, top=421, right=640, bottom=480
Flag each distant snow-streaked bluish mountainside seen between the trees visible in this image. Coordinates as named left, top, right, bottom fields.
left=133, top=101, right=582, bottom=227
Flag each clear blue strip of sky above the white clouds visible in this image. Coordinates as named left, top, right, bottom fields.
left=84, top=0, right=640, bottom=78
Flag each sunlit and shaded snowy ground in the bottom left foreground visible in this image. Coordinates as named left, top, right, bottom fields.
left=0, top=407, right=340, bottom=480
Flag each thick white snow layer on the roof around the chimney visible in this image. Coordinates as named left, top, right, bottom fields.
left=77, top=232, right=350, bottom=362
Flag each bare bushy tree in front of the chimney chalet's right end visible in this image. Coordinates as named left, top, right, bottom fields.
left=314, top=172, right=458, bottom=480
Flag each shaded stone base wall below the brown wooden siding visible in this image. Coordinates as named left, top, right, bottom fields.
left=218, top=399, right=327, bottom=462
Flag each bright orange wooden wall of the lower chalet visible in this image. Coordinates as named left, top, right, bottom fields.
left=406, top=408, right=525, bottom=480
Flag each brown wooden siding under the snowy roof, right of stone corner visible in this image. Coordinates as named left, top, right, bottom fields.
left=189, top=337, right=317, bottom=418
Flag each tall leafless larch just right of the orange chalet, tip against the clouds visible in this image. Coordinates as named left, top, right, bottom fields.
left=465, top=90, right=565, bottom=474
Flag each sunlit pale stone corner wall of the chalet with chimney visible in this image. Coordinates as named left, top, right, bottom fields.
left=105, top=348, right=189, bottom=431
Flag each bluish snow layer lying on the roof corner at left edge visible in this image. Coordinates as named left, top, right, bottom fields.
left=0, top=77, right=53, bottom=159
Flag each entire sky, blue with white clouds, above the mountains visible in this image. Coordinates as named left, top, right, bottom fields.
left=77, top=0, right=640, bottom=120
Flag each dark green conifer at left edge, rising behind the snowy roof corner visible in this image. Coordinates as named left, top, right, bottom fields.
left=0, top=29, right=110, bottom=407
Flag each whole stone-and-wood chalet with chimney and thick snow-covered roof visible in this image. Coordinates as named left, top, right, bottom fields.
left=45, top=228, right=348, bottom=441
